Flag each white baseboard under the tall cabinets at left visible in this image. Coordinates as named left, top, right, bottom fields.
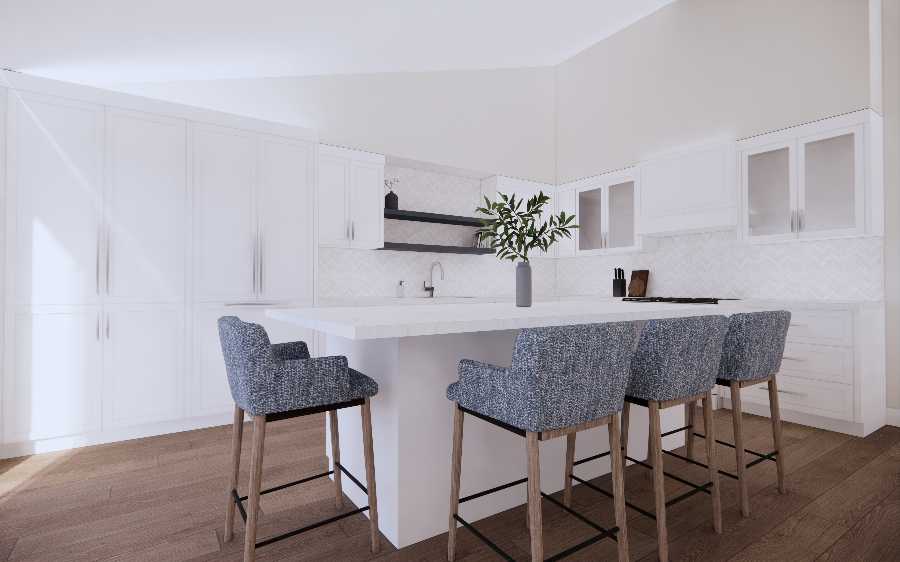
left=0, top=414, right=233, bottom=459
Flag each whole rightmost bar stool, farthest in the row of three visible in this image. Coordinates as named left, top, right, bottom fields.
left=686, top=310, right=791, bottom=517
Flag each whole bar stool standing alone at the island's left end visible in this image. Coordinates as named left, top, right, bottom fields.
left=218, top=316, right=379, bottom=562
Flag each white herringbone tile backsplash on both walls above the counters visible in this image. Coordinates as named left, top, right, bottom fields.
left=319, top=166, right=884, bottom=301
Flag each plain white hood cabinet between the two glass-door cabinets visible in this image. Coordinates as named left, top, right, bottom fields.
left=639, top=142, right=737, bottom=235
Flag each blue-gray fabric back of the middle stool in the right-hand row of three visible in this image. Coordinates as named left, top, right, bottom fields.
left=626, top=316, right=728, bottom=400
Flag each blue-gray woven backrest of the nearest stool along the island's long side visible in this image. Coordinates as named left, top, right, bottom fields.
left=510, top=322, right=636, bottom=427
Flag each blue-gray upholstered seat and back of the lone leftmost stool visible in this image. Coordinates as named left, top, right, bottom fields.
left=219, top=316, right=378, bottom=415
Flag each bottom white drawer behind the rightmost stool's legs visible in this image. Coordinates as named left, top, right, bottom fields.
left=741, top=375, right=853, bottom=421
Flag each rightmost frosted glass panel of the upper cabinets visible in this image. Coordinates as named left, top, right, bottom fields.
left=799, top=133, right=857, bottom=232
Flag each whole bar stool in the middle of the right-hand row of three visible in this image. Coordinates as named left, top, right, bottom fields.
left=622, top=316, right=728, bottom=562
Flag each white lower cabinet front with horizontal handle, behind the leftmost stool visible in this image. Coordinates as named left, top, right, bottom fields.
left=189, top=305, right=314, bottom=416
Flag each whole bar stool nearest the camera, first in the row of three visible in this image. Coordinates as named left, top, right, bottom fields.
left=447, top=322, right=635, bottom=561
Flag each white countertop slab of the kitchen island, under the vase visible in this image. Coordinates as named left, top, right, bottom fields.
left=266, top=299, right=775, bottom=340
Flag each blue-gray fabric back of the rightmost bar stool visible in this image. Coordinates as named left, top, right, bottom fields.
left=718, top=310, right=791, bottom=381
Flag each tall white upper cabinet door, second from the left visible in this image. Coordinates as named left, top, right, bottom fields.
left=103, top=110, right=187, bottom=302
